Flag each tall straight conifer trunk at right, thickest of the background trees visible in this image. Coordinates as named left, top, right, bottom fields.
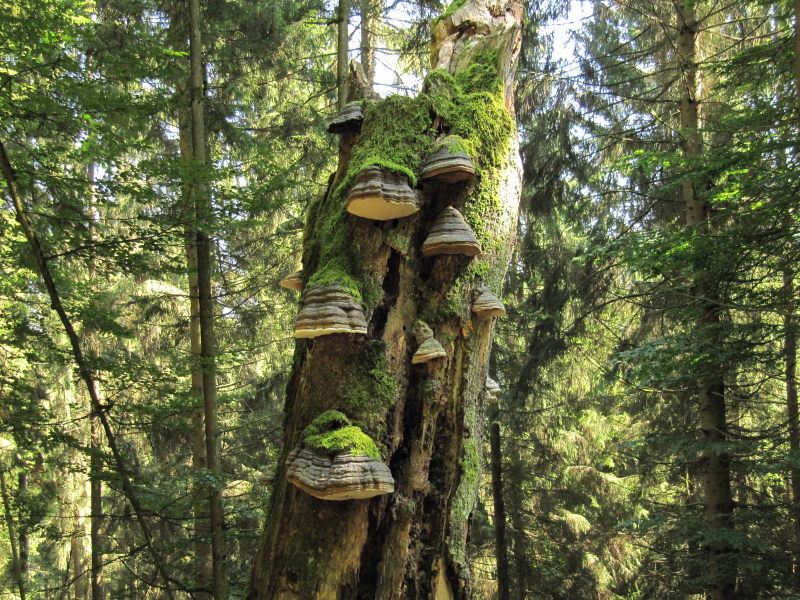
left=678, top=1, right=736, bottom=600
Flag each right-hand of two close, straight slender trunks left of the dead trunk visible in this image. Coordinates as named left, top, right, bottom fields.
left=189, top=0, right=226, bottom=600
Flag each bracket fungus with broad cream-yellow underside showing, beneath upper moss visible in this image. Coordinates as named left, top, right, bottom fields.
left=347, top=165, right=419, bottom=221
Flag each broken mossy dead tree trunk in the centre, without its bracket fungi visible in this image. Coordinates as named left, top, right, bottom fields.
left=247, top=0, right=522, bottom=600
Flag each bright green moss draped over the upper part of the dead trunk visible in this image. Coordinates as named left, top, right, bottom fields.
left=306, top=51, right=514, bottom=314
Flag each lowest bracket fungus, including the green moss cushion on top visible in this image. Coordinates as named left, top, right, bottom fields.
left=286, top=410, right=394, bottom=500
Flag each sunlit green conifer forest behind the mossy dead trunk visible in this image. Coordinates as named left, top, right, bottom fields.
left=0, top=0, right=800, bottom=600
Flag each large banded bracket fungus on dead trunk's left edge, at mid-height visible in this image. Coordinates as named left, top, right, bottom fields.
left=294, top=284, right=367, bottom=338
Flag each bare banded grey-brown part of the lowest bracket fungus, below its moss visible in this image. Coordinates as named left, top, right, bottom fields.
left=286, top=446, right=394, bottom=500
